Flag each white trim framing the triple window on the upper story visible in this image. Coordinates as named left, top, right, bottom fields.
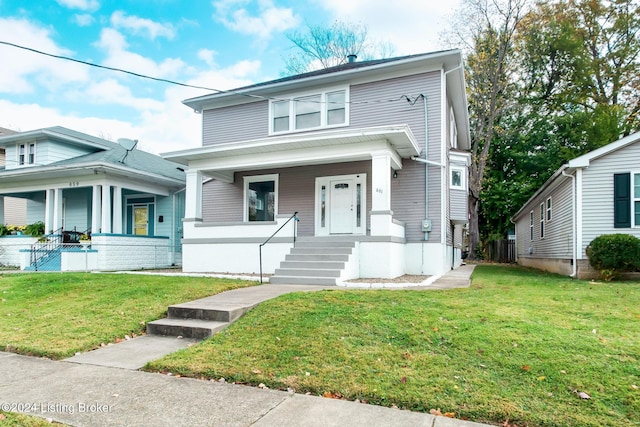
left=269, top=86, right=350, bottom=135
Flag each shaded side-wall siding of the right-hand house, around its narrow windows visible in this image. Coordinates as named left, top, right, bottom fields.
left=516, top=176, right=574, bottom=259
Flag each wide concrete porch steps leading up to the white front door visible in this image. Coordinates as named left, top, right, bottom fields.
left=269, top=238, right=355, bottom=286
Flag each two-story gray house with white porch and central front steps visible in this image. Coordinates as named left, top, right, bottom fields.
left=163, top=50, right=470, bottom=284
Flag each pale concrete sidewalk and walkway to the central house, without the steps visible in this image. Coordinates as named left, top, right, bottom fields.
left=0, top=266, right=490, bottom=427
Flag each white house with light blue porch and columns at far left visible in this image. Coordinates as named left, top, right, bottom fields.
left=0, top=127, right=185, bottom=270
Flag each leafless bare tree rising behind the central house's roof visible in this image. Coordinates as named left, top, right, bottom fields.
left=283, top=21, right=393, bottom=75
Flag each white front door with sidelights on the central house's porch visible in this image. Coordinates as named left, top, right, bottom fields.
left=315, top=174, right=367, bottom=236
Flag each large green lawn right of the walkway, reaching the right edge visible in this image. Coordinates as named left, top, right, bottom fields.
left=147, top=265, right=640, bottom=427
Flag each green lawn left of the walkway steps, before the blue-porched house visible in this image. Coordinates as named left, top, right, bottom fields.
left=0, top=273, right=255, bottom=359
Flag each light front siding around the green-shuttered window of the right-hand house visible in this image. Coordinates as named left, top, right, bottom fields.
left=582, top=143, right=640, bottom=257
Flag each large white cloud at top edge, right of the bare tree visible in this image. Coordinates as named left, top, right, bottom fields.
left=316, top=0, right=460, bottom=55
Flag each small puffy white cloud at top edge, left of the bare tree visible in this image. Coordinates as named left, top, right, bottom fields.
left=213, top=0, right=300, bottom=40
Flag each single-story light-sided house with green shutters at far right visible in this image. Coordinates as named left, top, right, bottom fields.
left=512, top=133, right=640, bottom=278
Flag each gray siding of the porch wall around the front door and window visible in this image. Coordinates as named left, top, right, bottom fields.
left=202, top=162, right=371, bottom=236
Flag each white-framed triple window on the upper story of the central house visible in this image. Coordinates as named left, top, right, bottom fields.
left=269, top=89, right=349, bottom=134
